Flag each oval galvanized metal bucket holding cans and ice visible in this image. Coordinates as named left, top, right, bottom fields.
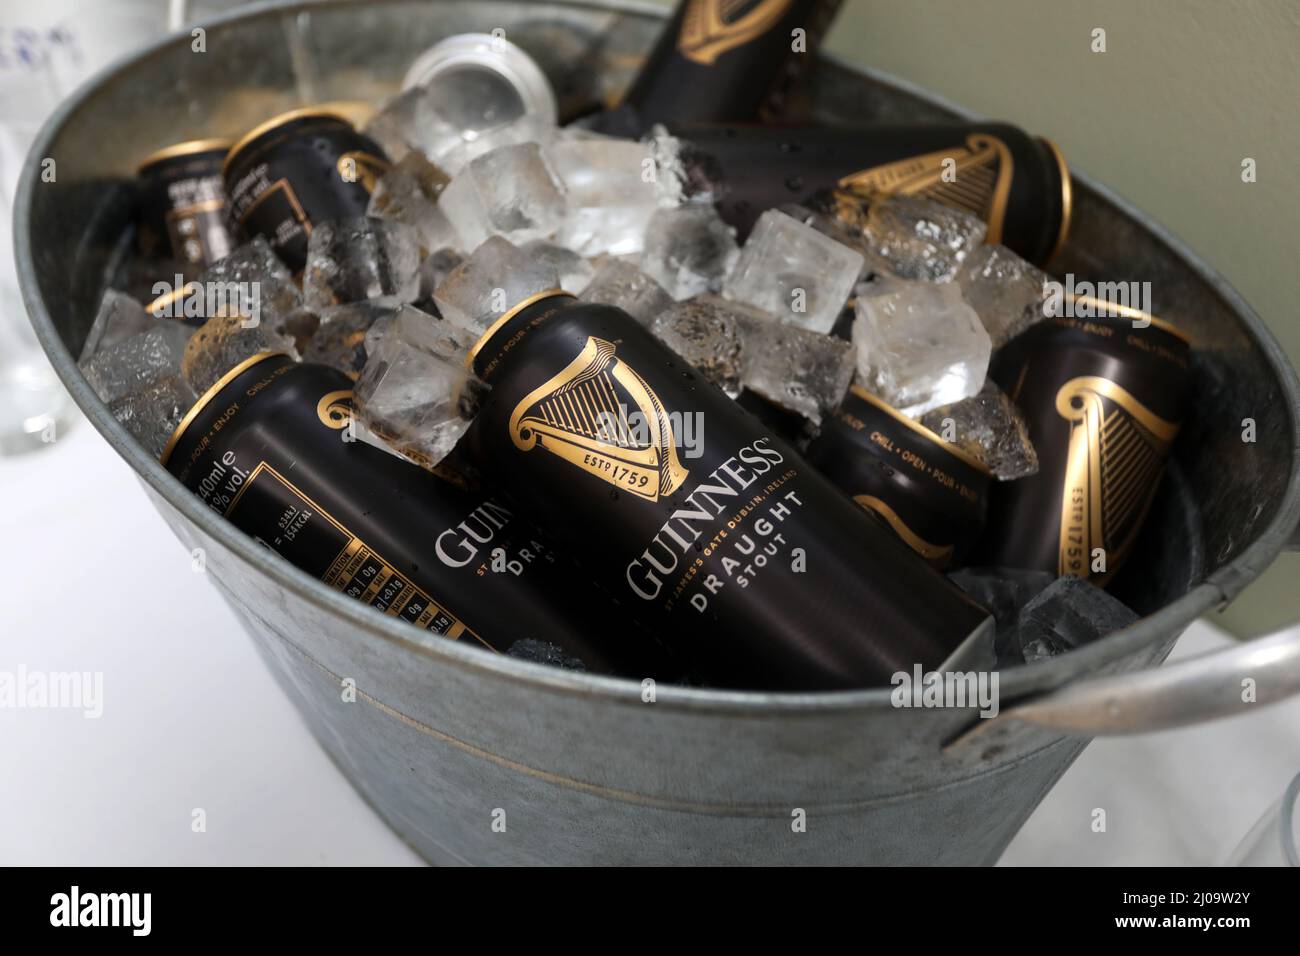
left=16, top=0, right=1300, bottom=864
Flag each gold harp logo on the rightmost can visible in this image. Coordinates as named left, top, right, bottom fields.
left=1056, top=376, right=1178, bottom=581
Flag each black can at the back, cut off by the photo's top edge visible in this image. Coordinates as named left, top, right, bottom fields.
left=595, top=0, right=840, bottom=137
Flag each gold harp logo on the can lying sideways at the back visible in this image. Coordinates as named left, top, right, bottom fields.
left=836, top=133, right=1014, bottom=242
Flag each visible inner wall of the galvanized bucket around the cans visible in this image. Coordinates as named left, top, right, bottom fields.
left=20, top=0, right=1296, bottom=634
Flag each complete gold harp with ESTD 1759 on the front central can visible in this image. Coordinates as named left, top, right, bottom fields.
left=510, top=336, right=688, bottom=501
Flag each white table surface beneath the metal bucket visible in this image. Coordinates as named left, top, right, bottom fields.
left=0, top=421, right=1300, bottom=865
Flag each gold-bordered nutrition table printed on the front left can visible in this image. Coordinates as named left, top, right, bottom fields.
left=225, top=462, right=490, bottom=646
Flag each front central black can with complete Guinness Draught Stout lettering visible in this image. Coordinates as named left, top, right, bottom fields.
left=462, top=290, right=989, bottom=689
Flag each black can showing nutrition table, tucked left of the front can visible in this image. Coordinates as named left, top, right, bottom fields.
left=161, top=352, right=658, bottom=676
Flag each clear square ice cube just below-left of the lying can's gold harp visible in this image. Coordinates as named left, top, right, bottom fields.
left=723, top=209, right=863, bottom=332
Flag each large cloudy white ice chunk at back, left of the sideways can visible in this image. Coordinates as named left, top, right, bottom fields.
left=546, top=138, right=659, bottom=256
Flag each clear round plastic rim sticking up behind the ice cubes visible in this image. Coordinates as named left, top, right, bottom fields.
left=402, top=34, right=559, bottom=126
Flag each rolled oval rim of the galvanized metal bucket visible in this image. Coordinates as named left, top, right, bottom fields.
left=13, top=0, right=1300, bottom=717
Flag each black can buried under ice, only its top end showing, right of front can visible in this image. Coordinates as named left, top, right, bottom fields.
left=809, top=385, right=992, bottom=568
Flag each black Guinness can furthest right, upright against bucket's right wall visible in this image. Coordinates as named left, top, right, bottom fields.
left=978, top=298, right=1191, bottom=587
